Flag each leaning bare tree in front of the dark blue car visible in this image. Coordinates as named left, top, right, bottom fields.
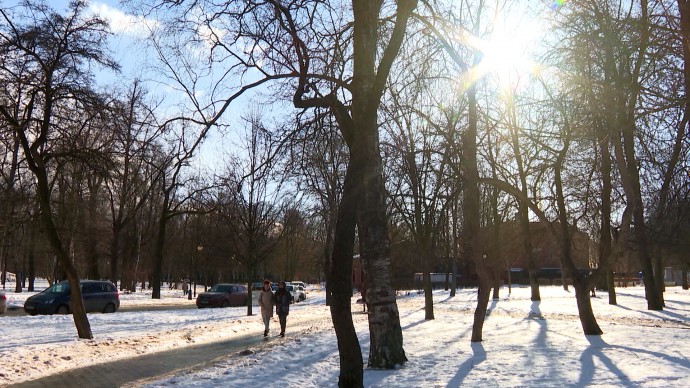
left=0, top=1, right=117, bottom=338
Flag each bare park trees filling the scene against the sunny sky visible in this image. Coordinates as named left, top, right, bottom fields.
left=0, top=0, right=690, bottom=386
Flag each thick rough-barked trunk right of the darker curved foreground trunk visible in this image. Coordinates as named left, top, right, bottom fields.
left=348, top=0, right=408, bottom=369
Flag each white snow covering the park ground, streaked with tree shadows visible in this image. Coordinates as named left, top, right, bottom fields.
left=0, top=280, right=690, bottom=387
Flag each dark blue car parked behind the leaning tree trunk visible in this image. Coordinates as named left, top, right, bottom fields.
left=24, top=280, right=120, bottom=315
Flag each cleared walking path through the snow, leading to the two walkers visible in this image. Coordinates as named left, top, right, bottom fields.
left=12, top=320, right=330, bottom=388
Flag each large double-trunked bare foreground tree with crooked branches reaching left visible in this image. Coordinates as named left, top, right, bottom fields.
left=134, top=0, right=417, bottom=386
